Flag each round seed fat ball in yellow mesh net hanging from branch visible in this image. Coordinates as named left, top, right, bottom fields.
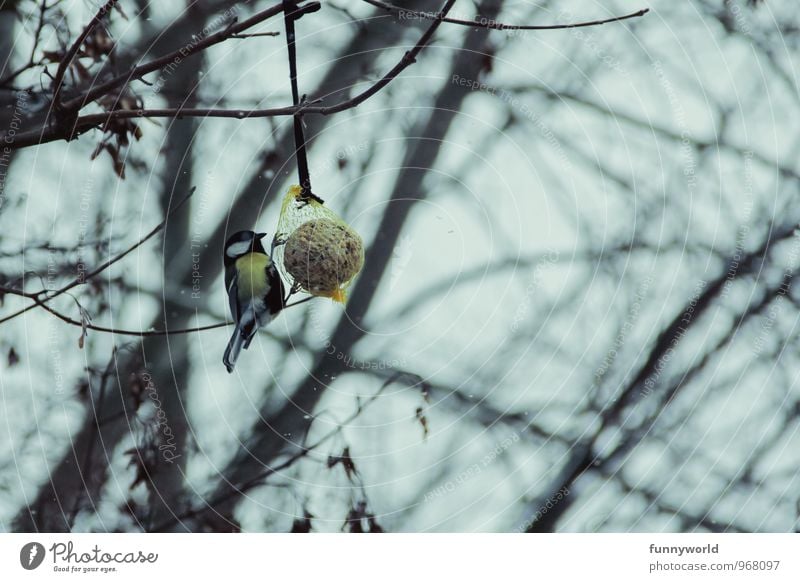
left=274, top=185, right=364, bottom=303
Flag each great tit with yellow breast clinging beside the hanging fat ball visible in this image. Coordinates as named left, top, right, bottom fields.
left=222, top=230, right=286, bottom=373
